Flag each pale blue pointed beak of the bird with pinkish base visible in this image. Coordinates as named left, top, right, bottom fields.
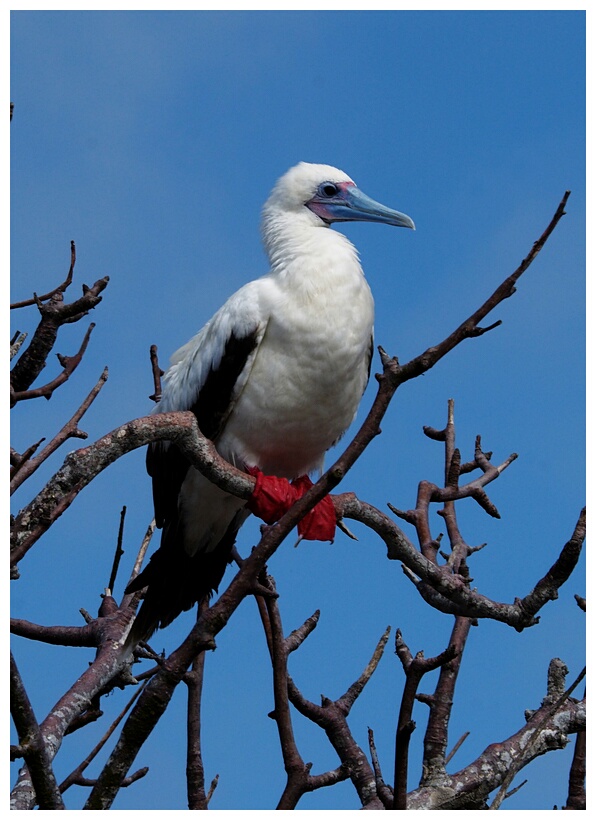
left=306, top=182, right=416, bottom=230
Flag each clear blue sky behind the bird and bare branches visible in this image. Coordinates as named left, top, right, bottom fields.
left=10, top=11, right=585, bottom=809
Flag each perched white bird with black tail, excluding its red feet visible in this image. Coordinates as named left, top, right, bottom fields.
left=126, top=162, right=415, bottom=646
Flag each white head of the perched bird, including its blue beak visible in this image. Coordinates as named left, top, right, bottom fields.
left=264, top=162, right=415, bottom=228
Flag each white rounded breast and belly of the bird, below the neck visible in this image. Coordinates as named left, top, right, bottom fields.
left=218, top=274, right=373, bottom=478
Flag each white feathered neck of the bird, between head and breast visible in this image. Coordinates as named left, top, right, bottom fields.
left=263, top=216, right=363, bottom=287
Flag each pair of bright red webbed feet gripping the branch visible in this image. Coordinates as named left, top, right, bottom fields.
left=246, top=467, right=337, bottom=541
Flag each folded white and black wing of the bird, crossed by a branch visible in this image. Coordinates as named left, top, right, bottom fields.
left=147, top=279, right=269, bottom=527
